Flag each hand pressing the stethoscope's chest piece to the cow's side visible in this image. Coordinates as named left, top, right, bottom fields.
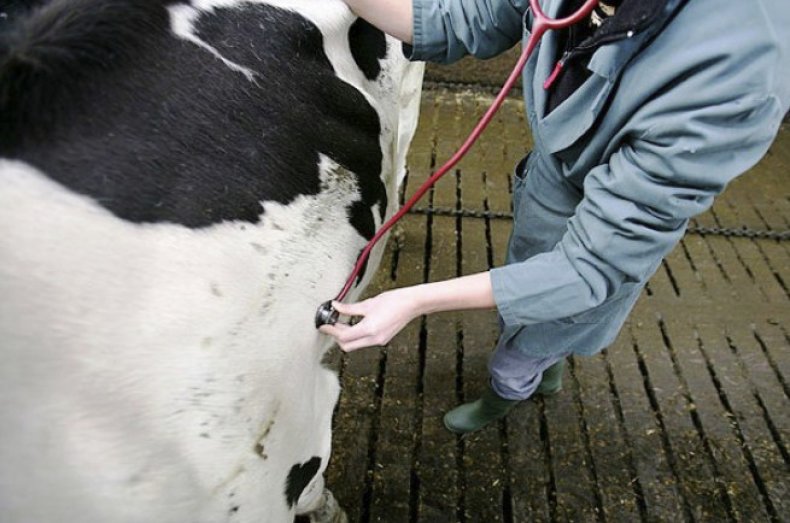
left=318, top=287, right=421, bottom=352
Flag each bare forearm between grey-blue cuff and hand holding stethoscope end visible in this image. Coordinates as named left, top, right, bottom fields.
left=410, top=272, right=495, bottom=314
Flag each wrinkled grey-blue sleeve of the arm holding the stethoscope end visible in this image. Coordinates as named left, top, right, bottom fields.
left=491, top=92, right=787, bottom=325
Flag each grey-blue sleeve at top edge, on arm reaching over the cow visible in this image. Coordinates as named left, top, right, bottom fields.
left=404, top=0, right=529, bottom=63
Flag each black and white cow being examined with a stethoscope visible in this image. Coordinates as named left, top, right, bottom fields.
left=0, top=0, right=422, bottom=523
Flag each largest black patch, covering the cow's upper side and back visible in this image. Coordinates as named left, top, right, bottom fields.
left=0, top=0, right=386, bottom=238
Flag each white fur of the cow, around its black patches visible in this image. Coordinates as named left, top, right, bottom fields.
left=0, top=0, right=421, bottom=523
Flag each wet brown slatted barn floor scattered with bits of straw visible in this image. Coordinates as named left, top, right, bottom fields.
left=327, top=90, right=790, bottom=523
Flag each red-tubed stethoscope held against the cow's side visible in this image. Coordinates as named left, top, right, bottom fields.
left=315, top=0, right=598, bottom=328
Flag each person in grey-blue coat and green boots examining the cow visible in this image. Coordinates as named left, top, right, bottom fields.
left=322, top=0, right=790, bottom=433
